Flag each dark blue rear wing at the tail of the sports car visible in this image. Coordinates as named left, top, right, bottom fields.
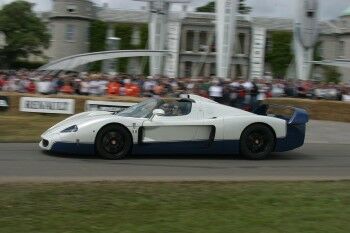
left=253, top=104, right=309, bottom=125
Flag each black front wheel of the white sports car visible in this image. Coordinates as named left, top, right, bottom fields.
left=95, top=125, right=132, bottom=160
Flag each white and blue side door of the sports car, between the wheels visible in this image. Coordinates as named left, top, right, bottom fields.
left=139, top=100, right=222, bottom=153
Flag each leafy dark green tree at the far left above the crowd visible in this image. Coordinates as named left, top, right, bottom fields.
left=0, top=1, right=50, bottom=67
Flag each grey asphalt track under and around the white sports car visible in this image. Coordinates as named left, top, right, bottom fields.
left=0, top=122, right=350, bottom=183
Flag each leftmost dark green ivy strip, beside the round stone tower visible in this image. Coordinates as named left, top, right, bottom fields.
left=90, top=20, right=107, bottom=72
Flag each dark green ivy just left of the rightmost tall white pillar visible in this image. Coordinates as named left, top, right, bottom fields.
left=266, top=31, right=293, bottom=77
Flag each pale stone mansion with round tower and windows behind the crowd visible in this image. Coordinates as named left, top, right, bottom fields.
left=39, top=0, right=350, bottom=81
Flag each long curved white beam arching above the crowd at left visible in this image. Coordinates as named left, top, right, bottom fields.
left=38, top=50, right=171, bottom=71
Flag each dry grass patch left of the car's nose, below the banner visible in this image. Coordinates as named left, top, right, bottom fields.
left=0, top=113, right=68, bottom=142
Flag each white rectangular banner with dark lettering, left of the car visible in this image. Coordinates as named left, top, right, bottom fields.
left=19, top=97, right=75, bottom=114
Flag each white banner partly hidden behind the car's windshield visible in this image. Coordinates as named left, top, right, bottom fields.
left=85, top=100, right=136, bottom=112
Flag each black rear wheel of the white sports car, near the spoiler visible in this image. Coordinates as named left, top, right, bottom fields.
left=240, top=124, right=276, bottom=160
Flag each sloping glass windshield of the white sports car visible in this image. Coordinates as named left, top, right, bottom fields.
left=116, top=99, right=164, bottom=118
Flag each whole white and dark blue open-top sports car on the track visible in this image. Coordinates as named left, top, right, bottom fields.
left=40, top=95, right=308, bottom=159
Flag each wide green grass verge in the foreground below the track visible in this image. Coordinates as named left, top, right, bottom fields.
left=0, top=181, right=350, bottom=233
